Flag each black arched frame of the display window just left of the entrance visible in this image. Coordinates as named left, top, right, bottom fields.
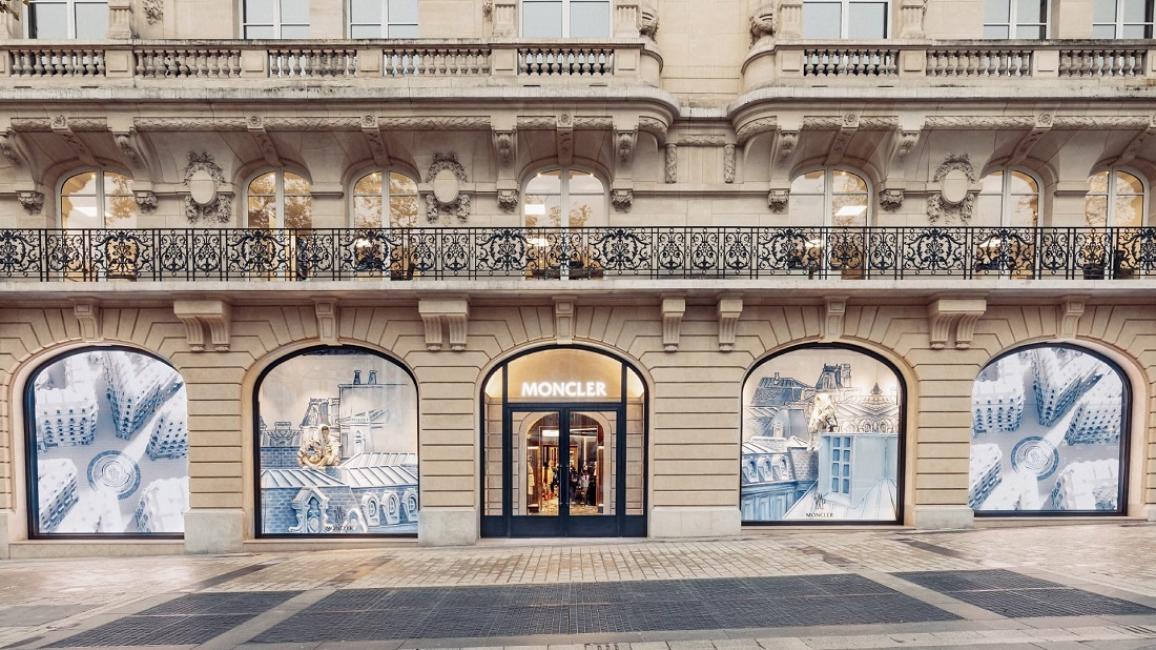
left=249, top=344, right=422, bottom=539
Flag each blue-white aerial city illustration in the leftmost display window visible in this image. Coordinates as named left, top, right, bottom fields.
left=30, top=349, right=188, bottom=535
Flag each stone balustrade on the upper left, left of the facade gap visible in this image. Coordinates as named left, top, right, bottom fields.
left=0, top=38, right=661, bottom=86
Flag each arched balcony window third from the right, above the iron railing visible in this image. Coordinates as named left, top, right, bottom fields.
left=790, top=169, right=870, bottom=226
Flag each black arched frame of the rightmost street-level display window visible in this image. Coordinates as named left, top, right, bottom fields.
left=969, top=341, right=1135, bottom=518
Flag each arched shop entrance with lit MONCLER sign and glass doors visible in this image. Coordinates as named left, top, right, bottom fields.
left=482, top=346, right=646, bottom=537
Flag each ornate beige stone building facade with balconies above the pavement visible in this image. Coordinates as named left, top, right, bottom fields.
left=0, top=0, right=1156, bottom=556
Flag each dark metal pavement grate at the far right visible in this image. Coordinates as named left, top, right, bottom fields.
left=896, top=569, right=1156, bottom=619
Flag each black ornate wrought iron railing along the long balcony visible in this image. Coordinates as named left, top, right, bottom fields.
left=0, top=227, right=1156, bottom=282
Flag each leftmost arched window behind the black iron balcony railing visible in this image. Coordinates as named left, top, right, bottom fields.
left=59, top=169, right=139, bottom=228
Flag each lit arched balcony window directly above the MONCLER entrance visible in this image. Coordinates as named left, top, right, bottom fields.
left=523, top=168, right=607, bottom=228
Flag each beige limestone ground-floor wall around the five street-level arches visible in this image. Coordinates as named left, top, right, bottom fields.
left=0, top=296, right=1156, bottom=551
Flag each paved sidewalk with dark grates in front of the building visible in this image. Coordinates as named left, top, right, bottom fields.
left=0, top=523, right=1156, bottom=650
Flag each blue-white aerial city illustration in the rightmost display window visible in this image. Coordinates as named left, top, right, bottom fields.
left=969, top=346, right=1127, bottom=514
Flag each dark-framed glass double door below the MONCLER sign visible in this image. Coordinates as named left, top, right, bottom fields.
left=507, top=407, right=624, bottom=537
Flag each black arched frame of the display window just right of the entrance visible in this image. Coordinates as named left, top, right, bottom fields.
left=739, top=344, right=909, bottom=526
